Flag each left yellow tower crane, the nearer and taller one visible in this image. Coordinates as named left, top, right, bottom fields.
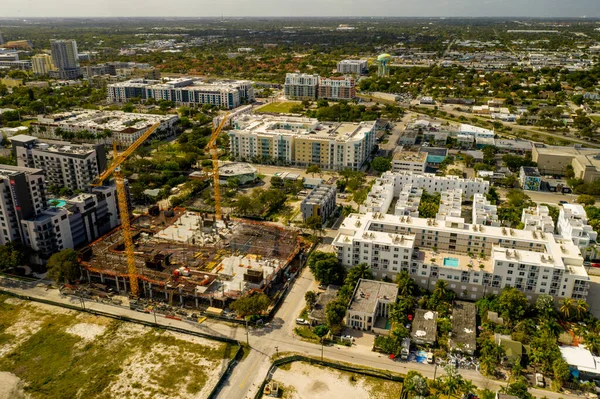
left=92, top=123, right=160, bottom=297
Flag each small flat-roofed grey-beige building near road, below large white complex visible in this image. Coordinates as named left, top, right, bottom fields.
left=346, top=278, right=398, bottom=335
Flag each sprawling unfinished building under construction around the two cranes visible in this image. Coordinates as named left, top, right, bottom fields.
left=81, top=208, right=304, bottom=307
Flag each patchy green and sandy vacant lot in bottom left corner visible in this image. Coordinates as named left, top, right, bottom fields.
left=0, top=295, right=236, bottom=399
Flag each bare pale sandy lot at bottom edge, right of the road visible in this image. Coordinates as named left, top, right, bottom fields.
left=273, top=362, right=394, bottom=399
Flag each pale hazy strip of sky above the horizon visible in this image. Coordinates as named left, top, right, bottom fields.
left=0, top=0, right=600, bottom=18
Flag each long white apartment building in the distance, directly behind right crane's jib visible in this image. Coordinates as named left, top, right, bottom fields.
left=106, top=77, right=254, bottom=109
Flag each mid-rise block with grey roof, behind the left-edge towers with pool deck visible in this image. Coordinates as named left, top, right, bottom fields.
left=10, top=134, right=106, bottom=190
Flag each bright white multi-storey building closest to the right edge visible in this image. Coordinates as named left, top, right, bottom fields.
left=556, top=204, right=598, bottom=255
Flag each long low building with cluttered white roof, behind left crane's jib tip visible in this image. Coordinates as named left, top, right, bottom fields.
left=30, top=110, right=179, bottom=146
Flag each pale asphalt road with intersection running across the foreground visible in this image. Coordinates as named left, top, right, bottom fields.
left=0, top=276, right=591, bottom=399
